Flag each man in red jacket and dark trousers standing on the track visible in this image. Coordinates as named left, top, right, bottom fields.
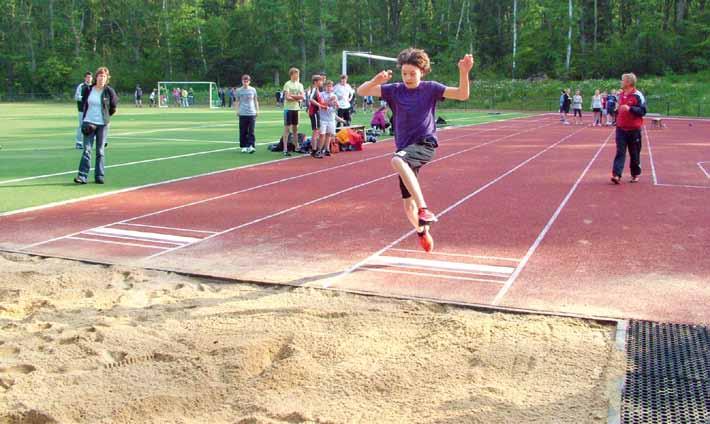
left=611, top=74, right=646, bottom=184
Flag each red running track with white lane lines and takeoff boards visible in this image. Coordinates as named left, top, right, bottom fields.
left=0, top=115, right=710, bottom=323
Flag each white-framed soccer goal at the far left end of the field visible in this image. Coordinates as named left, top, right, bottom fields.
left=158, top=81, right=221, bottom=109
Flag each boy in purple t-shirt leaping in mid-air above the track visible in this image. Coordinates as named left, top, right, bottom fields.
left=357, top=48, right=473, bottom=252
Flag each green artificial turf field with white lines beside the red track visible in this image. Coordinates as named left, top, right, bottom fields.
left=0, top=103, right=522, bottom=214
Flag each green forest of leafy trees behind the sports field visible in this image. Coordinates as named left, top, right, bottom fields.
left=0, top=0, right=710, bottom=98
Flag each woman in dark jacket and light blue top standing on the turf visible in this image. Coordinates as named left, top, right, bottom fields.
left=74, top=67, right=118, bottom=184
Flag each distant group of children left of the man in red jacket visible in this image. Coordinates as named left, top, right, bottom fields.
left=560, top=88, right=621, bottom=127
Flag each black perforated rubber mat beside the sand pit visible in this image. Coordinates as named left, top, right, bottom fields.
left=621, top=320, right=710, bottom=424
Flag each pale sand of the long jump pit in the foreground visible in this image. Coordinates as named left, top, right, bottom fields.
left=0, top=254, right=623, bottom=424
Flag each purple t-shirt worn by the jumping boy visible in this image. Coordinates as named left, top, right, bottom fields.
left=382, top=81, right=446, bottom=150
